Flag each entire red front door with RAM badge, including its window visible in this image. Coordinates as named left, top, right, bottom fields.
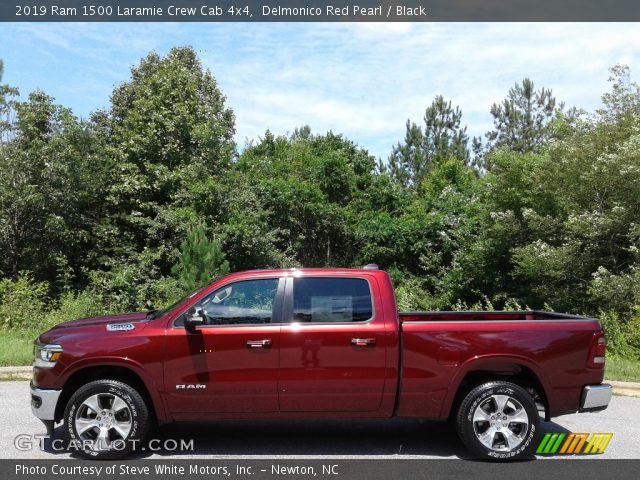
left=165, top=279, right=284, bottom=413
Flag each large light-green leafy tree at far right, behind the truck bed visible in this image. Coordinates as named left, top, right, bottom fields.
left=458, top=68, right=640, bottom=319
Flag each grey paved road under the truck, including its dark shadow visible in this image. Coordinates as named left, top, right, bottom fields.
left=0, top=381, right=640, bottom=459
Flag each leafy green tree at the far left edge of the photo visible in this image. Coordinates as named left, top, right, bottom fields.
left=0, top=91, right=103, bottom=280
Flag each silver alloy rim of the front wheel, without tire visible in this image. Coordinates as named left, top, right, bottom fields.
left=74, top=393, right=132, bottom=451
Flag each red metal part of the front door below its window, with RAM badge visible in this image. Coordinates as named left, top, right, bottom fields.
left=165, top=325, right=280, bottom=413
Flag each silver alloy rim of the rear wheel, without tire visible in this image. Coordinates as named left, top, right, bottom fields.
left=473, top=395, right=529, bottom=452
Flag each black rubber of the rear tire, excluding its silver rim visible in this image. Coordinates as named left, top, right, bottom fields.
left=458, top=384, right=540, bottom=461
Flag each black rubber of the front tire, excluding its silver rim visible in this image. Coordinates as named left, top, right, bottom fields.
left=64, top=381, right=146, bottom=459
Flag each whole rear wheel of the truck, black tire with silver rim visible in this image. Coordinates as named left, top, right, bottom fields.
left=456, top=381, right=540, bottom=461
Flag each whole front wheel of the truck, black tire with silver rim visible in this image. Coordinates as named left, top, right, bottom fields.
left=64, top=379, right=149, bottom=460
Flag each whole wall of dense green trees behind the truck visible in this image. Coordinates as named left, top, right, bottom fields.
left=0, top=48, right=640, bottom=357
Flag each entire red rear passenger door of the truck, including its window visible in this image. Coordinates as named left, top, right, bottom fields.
left=278, top=278, right=387, bottom=412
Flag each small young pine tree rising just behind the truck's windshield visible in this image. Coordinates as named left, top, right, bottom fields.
left=171, top=223, right=229, bottom=292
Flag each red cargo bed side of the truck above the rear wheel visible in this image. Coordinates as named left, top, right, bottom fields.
left=398, top=311, right=603, bottom=418
